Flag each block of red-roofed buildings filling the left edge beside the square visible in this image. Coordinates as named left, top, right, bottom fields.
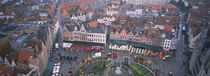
left=0, top=0, right=59, bottom=76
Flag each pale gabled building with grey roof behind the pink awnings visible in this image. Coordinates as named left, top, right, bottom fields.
left=63, top=25, right=106, bottom=44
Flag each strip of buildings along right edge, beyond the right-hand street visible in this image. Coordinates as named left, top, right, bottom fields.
left=185, top=0, right=210, bottom=76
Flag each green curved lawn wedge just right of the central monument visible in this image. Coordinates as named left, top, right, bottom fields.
left=129, top=64, right=152, bottom=76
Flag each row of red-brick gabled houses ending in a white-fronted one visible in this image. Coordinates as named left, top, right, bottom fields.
left=109, top=24, right=177, bottom=51
